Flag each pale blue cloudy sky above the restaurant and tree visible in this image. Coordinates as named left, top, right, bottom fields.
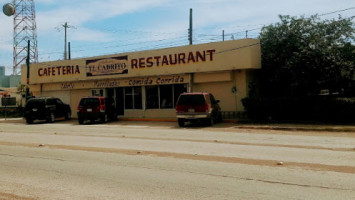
left=0, top=0, right=355, bottom=74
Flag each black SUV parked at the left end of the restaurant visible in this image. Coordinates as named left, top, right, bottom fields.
left=24, top=97, right=71, bottom=124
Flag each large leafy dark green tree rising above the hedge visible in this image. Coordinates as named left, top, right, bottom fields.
left=260, top=15, right=355, bottom=97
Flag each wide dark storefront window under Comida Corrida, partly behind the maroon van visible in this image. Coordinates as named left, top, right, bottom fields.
left=145, top=84, right=187, bottom=109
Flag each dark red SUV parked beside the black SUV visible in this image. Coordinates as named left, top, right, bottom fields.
left=78, top=96, right=117, bottom=124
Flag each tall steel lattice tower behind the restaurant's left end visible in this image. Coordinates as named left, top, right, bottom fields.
left=12, top=0, right=38, bottom=75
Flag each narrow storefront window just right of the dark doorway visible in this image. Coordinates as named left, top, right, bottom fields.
left=125, top=87, right=142, bottom=109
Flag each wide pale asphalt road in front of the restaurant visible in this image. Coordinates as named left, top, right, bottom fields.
left=0, top=120, right=355, bottom=200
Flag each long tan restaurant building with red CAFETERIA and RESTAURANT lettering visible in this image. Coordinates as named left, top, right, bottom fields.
left=21, top=39, right=261, bottom=119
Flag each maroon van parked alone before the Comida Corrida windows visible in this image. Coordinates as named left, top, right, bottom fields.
left=176, top=92, right=222, bottom=126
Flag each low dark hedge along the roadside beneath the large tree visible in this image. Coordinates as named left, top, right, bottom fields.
left=242, top=96, right=355, bottom=123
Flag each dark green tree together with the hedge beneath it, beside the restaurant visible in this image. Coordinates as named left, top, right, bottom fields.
left=242, top=16, right=355, bottom=123
